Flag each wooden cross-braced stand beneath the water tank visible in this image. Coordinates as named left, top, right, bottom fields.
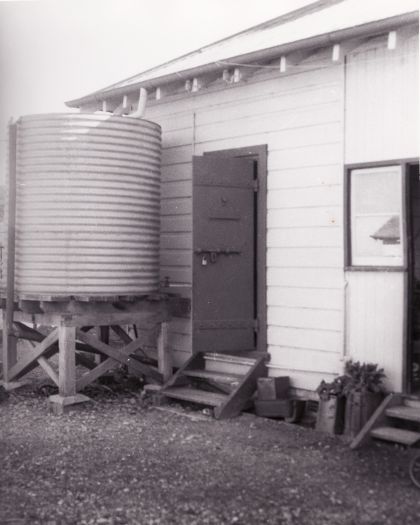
left=2, top=295, right=189, bottom=413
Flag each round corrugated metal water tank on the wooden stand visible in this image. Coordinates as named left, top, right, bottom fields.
left=15, top=113, right=161, bottom=298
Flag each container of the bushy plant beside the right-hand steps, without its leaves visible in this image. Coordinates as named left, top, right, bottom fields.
left=344, top=392, right=383, bottom=438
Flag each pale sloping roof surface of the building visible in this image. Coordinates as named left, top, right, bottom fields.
left=68, top=0, right=419, bottom=106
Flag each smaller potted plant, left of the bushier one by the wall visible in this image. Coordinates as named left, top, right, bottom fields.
left=316, top=376, right=346, bottom=434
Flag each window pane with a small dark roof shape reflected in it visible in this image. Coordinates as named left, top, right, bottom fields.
left=350, top=165, right=404, bottom=266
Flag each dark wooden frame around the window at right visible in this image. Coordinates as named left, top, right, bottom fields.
left=344, top=158, right=418, bottom=272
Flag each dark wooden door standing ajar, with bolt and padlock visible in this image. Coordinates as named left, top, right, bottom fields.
left=192, top=156, right=256, bottom=352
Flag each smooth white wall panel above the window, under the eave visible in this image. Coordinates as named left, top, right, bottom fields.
left=345, top=28, right=420, bottom=164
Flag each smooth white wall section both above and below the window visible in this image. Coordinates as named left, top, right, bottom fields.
left=345, top=28, right=419, bottom=391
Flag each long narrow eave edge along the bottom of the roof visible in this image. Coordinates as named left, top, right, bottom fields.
left=65, top=11, right=419, bottom=108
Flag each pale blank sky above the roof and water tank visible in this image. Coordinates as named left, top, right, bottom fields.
left=0, top=0, right=313, bottom=181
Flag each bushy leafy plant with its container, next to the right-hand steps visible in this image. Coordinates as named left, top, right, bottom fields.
left=343, top=360, right=385, bottom=438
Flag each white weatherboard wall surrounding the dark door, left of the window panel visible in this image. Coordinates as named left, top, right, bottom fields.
left=146, top=49, right=344, bottom=390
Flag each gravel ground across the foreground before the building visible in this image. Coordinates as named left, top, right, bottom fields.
left=0, top=380, right=420, bottom=525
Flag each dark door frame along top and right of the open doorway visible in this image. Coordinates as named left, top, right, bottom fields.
left=203, top=144, right=267, bottom=352
